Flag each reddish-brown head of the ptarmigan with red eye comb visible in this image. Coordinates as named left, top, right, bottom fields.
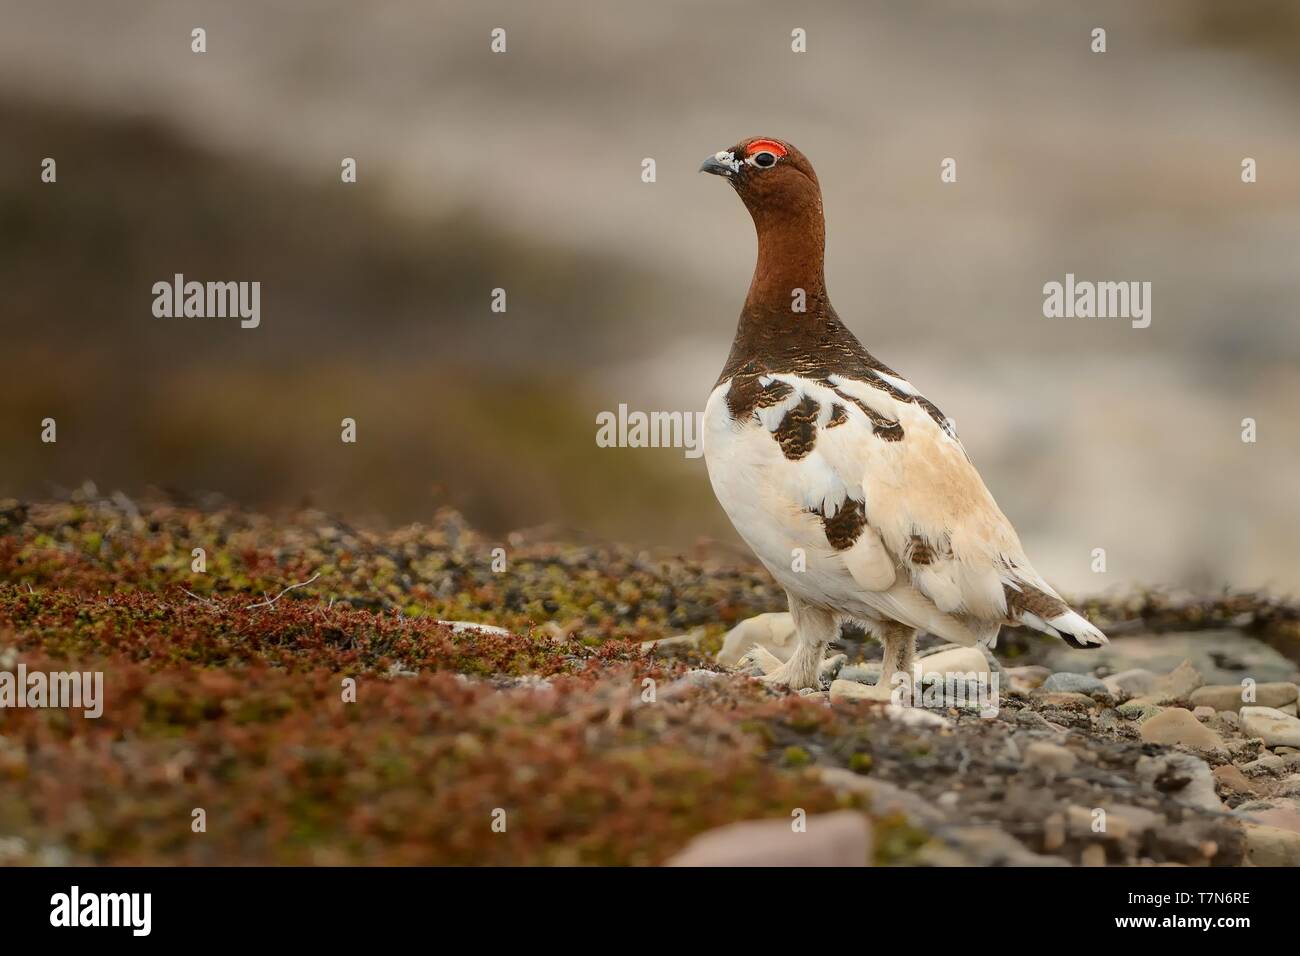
left=699, top=137, right=822, bottom=222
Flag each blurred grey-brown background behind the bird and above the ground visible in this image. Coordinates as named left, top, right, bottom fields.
left=0, top=0, right=1300, bottom=592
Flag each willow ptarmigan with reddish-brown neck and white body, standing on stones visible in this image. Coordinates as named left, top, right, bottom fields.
left=701, top=139, right=1106, bottom=689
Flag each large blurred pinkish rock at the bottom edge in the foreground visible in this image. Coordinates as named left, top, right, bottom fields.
left=667, top=810, right=872, bottom=866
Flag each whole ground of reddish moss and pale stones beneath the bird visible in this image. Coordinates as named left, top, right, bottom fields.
left=0, top=486, right=1300, bottom=866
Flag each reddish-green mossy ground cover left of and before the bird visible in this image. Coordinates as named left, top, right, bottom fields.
left=0, top=494, right=1295, bottom=864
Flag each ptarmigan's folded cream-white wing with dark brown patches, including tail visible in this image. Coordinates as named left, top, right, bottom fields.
left=755, top=368, right=1105, bottom=645
